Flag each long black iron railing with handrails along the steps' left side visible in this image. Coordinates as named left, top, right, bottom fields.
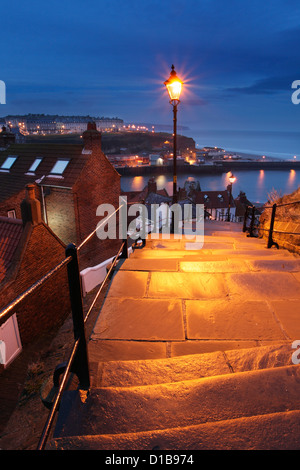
left=0, top=206, right=139, bottom=450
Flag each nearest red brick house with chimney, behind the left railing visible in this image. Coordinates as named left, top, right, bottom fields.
left=0, top=185, right=70, bottom=367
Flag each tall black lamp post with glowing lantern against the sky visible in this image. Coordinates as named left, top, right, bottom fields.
left=164, top=65, right=183, bottom=233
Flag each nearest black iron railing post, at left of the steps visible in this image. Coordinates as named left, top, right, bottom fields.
left=66, top=243, right=90, bottom=390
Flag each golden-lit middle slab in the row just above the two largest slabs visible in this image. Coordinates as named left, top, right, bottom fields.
left=148, top=272, right=227, bottom=299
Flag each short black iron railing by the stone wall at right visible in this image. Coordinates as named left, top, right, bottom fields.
left=243, top=201, right=300, bottom=248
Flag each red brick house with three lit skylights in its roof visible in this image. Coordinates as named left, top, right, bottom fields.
left=0, top=123, right=121, bottom=269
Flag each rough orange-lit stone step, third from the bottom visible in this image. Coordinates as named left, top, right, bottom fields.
left=91, top=342, right=292, bottom=387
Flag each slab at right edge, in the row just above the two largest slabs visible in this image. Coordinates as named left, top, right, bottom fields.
left=225, top=272, right=300, bottom=300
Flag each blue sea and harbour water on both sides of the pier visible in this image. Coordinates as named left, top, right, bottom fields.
left=121, top=129, right=300, bottom=204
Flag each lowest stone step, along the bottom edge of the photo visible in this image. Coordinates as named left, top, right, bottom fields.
left=48, top=410, right=300, bottom=452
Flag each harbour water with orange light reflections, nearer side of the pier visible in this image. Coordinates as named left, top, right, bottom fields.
left=121, top=170, right=300, bottom=203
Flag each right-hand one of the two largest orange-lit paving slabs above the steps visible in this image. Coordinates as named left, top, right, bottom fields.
left=186, top=300, right=286, bottom=340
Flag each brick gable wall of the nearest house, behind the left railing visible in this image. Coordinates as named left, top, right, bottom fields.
left=0, top=224, right=70, bottom=345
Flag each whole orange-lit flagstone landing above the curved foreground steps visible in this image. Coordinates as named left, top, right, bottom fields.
left=91, top=225, right=300, bottom=360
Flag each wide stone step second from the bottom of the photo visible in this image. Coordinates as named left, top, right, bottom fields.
left=54, top=365, right=300, bottom=438
